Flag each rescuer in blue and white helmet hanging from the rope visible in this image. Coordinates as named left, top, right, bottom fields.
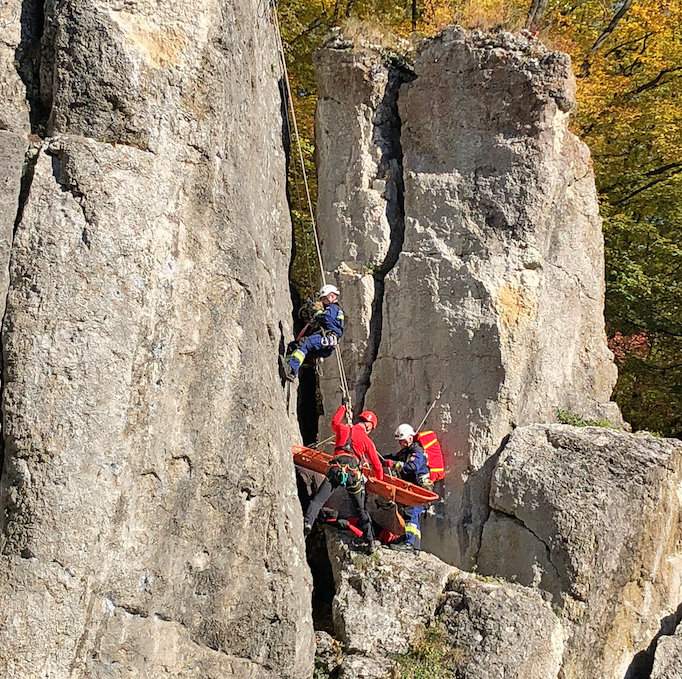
left=282, top=285, right=345, bottom=382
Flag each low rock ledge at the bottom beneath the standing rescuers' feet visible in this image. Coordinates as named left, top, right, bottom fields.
left=318, top=530, right=564, bottom=679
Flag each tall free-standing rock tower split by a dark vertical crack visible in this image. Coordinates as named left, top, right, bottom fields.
left=317, top=28, right=619, bottom=564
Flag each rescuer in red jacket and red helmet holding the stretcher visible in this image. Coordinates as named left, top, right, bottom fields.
left=303, top=405, right=384, bottom=551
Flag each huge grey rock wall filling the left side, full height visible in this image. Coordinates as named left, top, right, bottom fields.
left=0, top=0, right=313, bottom=679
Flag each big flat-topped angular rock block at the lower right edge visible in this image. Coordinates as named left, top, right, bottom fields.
left=478, top=425, right=682, bottom=679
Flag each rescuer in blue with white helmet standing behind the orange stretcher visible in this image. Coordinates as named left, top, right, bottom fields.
left=384, top=424, right=430, bottom=552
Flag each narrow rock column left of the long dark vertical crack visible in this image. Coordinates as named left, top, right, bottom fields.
left=315, top=48, right=412, bottom=412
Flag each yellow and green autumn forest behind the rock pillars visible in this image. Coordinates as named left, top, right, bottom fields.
left=278, top=0, right=682, bottom=438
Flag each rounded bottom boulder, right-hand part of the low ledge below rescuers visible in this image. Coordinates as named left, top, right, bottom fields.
left=436, top=573, right=564, bottom=679
